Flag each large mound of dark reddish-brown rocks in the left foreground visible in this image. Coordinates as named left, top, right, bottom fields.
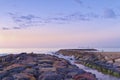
left=0, top=53, right=97, bottom=80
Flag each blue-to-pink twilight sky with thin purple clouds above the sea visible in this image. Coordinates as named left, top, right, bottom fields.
left=0, top=0, right=120, bottom=48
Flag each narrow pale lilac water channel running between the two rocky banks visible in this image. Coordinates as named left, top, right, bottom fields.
left=53, top=54, right=120, bottom=80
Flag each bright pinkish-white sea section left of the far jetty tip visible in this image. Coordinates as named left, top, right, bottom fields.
left=0, top=48, right=61, bottom=55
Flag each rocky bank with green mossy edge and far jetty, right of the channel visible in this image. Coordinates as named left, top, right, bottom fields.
left=56, top=49, right=120, bottom=78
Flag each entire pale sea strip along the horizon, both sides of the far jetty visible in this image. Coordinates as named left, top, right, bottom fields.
left=0, top=48, right=120, bottom=54
